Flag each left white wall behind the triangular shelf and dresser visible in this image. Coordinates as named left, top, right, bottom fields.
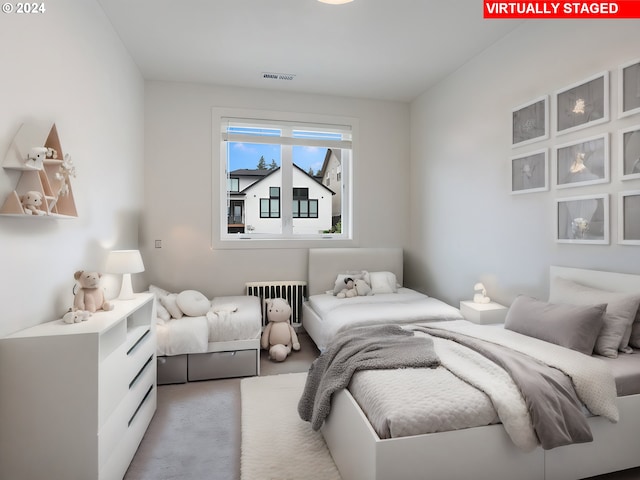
left=0, top=0, right=144, bottom=335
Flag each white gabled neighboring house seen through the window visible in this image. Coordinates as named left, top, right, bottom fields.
left=228, top=166, right=335, bottom=235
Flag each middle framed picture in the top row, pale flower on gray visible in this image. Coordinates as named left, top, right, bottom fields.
left=556, top=71, right=609, bottom=134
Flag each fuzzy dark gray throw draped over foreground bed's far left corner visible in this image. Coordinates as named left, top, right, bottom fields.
left=298, top=325, right=440, bottom=430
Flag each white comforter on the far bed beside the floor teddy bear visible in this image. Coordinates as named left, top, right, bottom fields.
left=302, top=287, right=464, bottom=350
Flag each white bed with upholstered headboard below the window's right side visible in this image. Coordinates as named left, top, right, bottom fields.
left=302, top=248, right=464, bottom=351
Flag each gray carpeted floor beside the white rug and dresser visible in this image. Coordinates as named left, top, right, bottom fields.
left=124, top=334, right=318, bottom=480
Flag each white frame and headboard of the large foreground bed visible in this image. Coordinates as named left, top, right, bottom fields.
left=316, top=258, right=640, bottom=480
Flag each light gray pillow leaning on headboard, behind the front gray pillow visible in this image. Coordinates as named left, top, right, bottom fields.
left=549, top=277, right=640, bottom=358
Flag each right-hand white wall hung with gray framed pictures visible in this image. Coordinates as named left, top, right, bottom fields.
left=406, top=20, right=640, bottom=305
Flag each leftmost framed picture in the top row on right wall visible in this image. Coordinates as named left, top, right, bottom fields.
left=511, top=95, right=549, bottom=147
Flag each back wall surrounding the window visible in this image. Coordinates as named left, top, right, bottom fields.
left=140, top=81, right=410, bottom=296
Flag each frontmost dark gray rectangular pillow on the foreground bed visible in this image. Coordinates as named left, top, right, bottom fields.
left=504, top=295, right=607, bottom=355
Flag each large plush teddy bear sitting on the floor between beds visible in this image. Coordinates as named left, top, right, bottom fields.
left=260, top=298, right=300, bottom=362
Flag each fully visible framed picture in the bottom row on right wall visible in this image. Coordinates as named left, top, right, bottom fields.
left=556, top=194, right=609, bottom=245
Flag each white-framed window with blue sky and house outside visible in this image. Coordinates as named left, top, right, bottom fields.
left=214, top=109, right=353, bottom=241
